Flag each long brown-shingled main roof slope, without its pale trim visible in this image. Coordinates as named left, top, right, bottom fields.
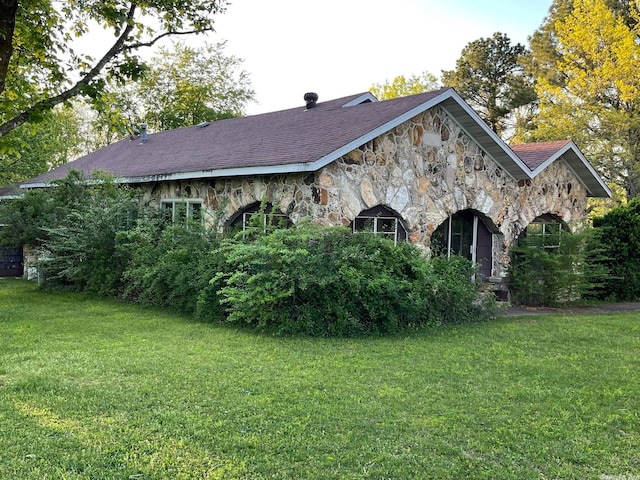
left=29, top=90, right=450, bottom=183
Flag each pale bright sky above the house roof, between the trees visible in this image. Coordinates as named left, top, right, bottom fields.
left=204, top=0, right=552, bottom=114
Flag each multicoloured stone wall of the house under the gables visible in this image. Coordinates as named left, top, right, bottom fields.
left=141, top=107, right=587, bottom=277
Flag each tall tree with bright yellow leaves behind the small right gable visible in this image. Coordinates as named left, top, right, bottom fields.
left=533, top=0, right=640, bottom=198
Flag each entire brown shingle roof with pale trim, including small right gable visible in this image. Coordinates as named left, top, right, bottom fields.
left=22, top=88, right=610, bottom=196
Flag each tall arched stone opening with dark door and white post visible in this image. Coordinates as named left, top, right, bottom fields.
left=431, top=210, right=495, bottom=280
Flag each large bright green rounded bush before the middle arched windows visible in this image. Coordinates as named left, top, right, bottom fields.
left=212, top=226, right=492, bottom=335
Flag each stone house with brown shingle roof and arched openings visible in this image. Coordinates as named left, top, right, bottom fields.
left=22, top=88, right=610, bottom=294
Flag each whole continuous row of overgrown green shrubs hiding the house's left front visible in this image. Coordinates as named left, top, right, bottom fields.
left=2, top=172, right=490, bottom=336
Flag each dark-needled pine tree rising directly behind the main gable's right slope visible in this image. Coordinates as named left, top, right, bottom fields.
left=442, top=32, right=535, bottom=135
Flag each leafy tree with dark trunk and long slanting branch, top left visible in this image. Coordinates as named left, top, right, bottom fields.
left=0, top=0, right=226, bottom=140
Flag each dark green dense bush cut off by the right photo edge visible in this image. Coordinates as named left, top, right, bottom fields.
left=591, top=197, right=640, bottom=301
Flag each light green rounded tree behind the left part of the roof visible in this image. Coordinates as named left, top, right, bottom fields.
left=135, top=43, right=255, bottom=130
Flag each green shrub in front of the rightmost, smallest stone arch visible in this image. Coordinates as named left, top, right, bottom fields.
left=508, top=230, right=609, bottom=306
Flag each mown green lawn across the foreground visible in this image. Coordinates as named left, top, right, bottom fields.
left=0, top=280, right=640, bottom=480
